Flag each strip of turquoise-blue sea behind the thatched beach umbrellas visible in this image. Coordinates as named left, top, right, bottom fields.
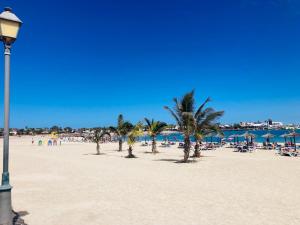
left=140, top=130, right=300, bottom=143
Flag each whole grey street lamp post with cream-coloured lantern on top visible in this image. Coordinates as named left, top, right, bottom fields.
left=0, top=8, right=22, bottom=225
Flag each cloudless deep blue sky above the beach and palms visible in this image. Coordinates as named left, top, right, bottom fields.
left=0, top=0, right=300, bottom=127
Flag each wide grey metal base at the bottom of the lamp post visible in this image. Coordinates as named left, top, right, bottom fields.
left=0, top=185, right=13, bottom=225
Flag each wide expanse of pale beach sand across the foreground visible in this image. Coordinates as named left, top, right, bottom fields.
left=0, top=137, right=300, bottom=225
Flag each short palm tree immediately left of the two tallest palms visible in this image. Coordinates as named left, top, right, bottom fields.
left=145, top=118, right=167, bottom=153
